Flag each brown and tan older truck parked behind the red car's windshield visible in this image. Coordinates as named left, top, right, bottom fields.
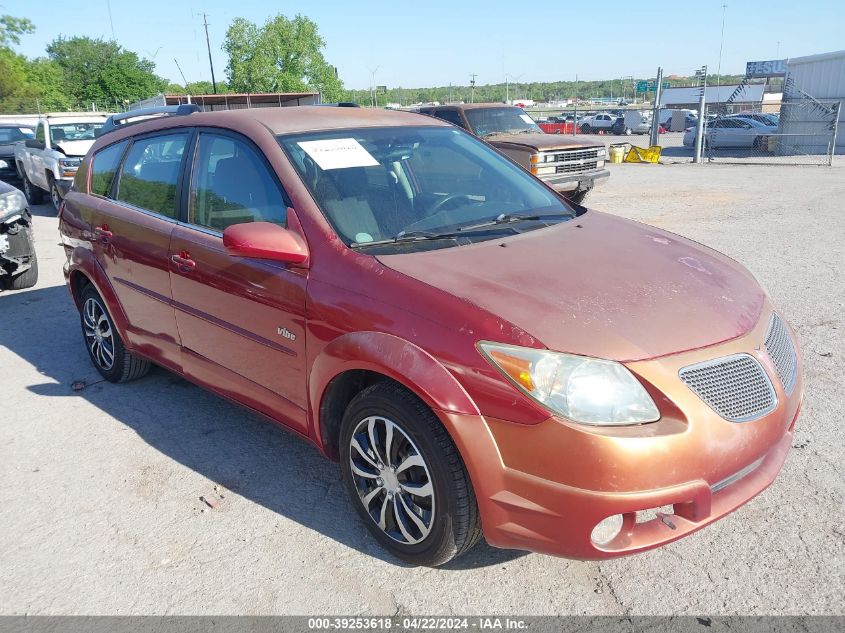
left=419, top=103, right=610, bottom=203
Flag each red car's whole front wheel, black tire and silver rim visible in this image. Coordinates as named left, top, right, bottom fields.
left=340, top=382, right=481, bottom=567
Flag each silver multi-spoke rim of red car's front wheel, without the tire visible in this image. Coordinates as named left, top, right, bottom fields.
left=349, top=416, right=435, bottom=545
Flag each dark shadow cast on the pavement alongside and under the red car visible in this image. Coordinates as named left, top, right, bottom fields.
left=0, top=286, right=525, bottom=570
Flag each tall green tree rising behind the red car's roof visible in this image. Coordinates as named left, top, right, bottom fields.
left=223, top=14, right=345, bottom=101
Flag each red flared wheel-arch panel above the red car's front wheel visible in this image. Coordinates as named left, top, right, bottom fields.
left=308, top=331, right=479, bottom=438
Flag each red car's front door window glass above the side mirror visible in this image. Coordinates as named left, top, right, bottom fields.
left=189, top=133, right=287, bottom=231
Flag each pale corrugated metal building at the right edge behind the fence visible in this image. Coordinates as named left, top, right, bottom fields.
left=778, top=51, right=845, bottom=154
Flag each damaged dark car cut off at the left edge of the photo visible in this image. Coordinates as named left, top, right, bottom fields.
left=0, top=181, right=38, bottom=290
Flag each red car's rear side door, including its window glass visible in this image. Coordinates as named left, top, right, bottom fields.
left=91, top=130, right=191, bottom=370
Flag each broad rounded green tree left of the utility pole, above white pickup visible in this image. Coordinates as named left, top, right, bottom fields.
left=47, top=37, right=167, bottom=104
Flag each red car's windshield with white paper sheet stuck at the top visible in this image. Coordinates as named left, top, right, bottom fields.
left=279, top=127, right=575, bottom=252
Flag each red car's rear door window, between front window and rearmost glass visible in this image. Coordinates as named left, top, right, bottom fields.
left=117, top=133, right=188, bottom=219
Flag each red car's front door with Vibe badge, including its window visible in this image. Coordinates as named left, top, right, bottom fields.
left=170, top=131, right=307, bottom=432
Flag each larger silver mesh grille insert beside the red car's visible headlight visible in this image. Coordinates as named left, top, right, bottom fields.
left=678, top=354, right=777, bottom=422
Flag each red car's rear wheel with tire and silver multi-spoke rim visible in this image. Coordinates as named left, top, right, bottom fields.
left=79, top=285, right=150, bottom=382
